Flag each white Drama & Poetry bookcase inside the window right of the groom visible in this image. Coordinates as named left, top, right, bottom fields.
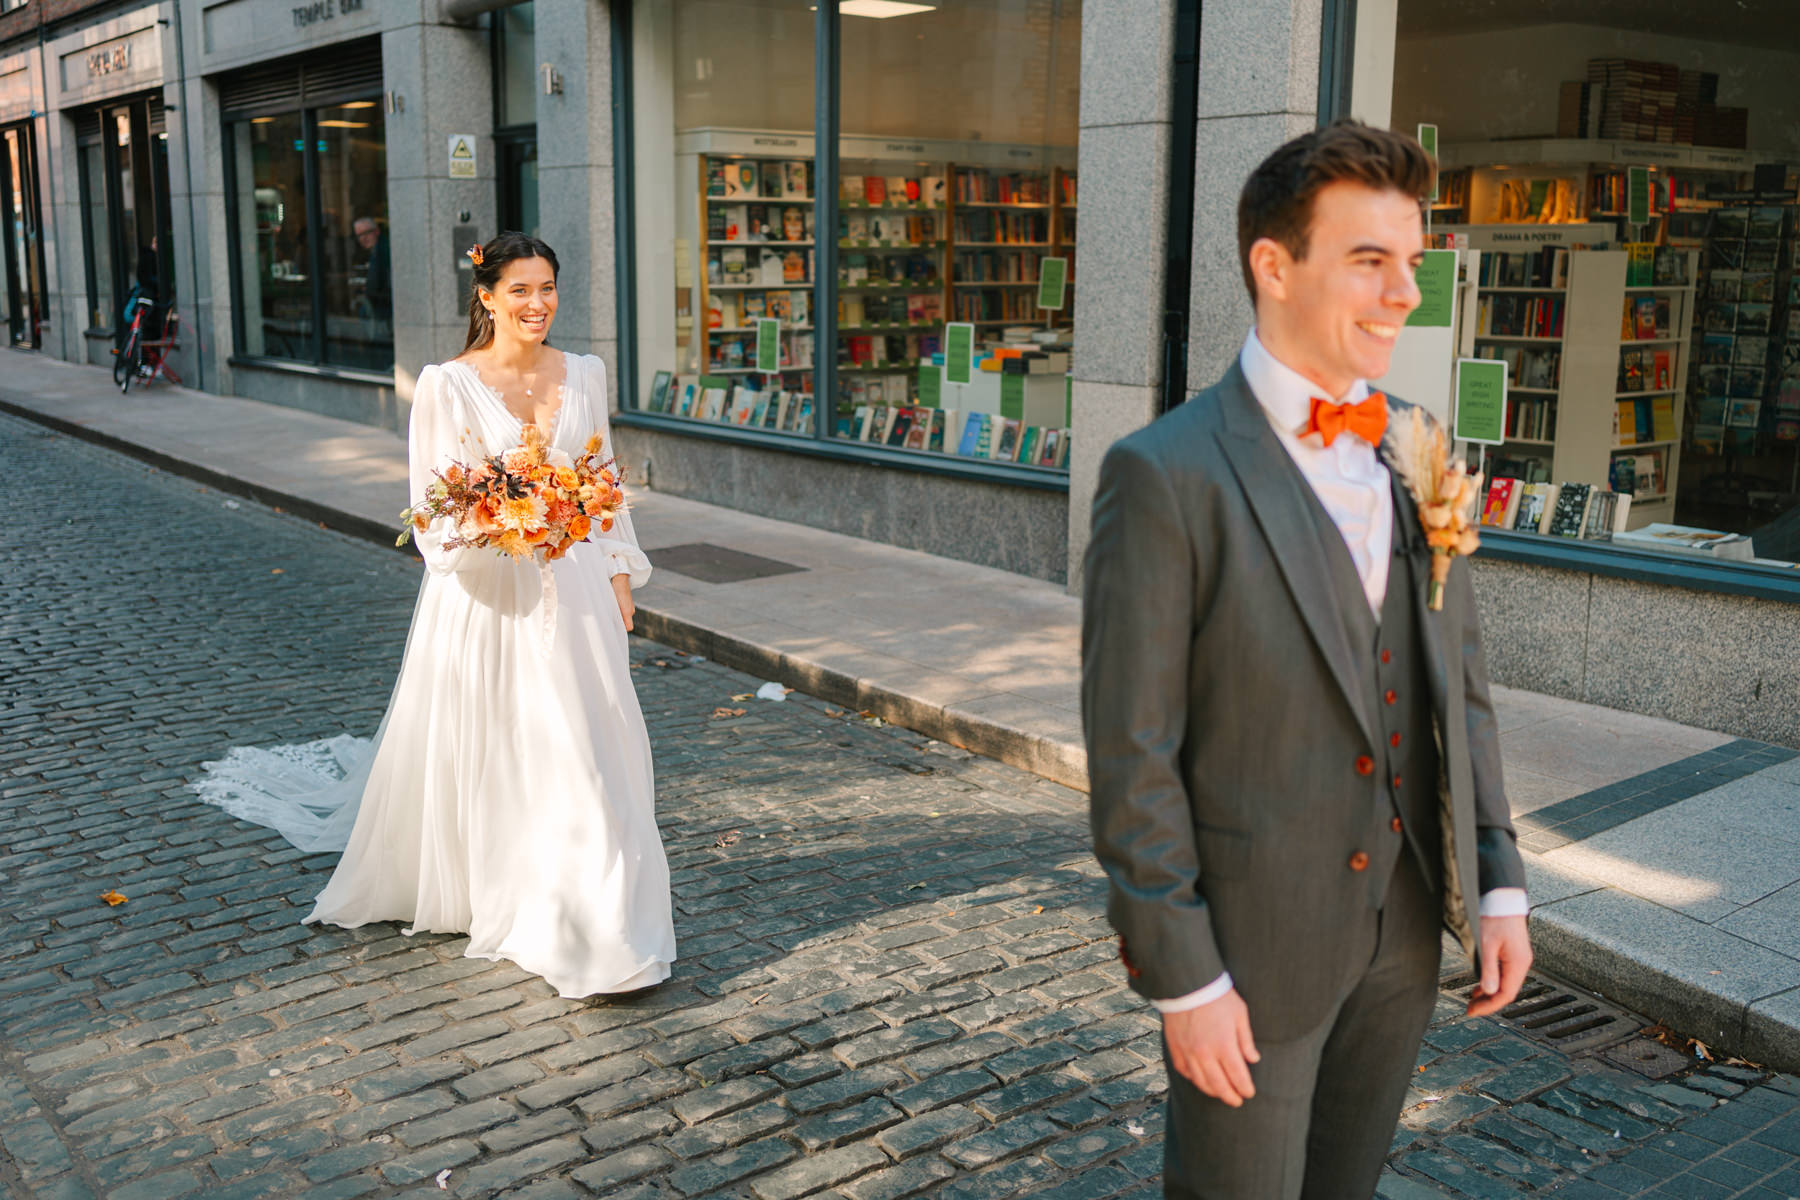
left=1453, top=225, right=1699, bottom=529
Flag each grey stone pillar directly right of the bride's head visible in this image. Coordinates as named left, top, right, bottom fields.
left=536, top=0, right=628, bottom=372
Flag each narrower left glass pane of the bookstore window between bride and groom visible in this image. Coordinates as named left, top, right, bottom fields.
left=630, top=0, right=817, bottom=437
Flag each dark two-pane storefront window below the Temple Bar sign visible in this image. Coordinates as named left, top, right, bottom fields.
left=227, top=99, right=394, bottom=371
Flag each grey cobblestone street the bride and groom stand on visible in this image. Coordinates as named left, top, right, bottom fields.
left=0, top=416, right=1800, bottom=1200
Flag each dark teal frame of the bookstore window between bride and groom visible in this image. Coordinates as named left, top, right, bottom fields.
left=608, top=0, right=1069, bottom=493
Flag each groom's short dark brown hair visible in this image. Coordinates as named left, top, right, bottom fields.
left=1238, top=121, right=1436, bottom=304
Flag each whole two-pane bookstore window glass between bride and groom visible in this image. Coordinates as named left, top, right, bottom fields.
left=634, top=0, right=1082, bottom=471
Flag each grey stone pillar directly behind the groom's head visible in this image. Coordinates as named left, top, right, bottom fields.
left=1188, top=0, right=1321, bottom=392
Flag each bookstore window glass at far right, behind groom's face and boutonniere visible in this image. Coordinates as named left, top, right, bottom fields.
left=1391, top=0, right=1800, bottom=567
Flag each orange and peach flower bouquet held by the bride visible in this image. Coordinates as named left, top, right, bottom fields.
left=394, top=425, right=625, bottom=561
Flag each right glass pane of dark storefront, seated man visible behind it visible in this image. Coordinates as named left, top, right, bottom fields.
left=315, top=101, right=394, bottom=371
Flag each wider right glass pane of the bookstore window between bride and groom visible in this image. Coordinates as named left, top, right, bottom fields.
left=830, top=0, right=1082, bottom=468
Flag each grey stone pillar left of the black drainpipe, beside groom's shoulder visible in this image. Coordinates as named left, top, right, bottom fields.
left=1067, top=0, right=1175, bottom=592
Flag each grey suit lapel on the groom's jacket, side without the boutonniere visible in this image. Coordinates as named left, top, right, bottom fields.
left=1219, top=363, right=1375, bottom=743
